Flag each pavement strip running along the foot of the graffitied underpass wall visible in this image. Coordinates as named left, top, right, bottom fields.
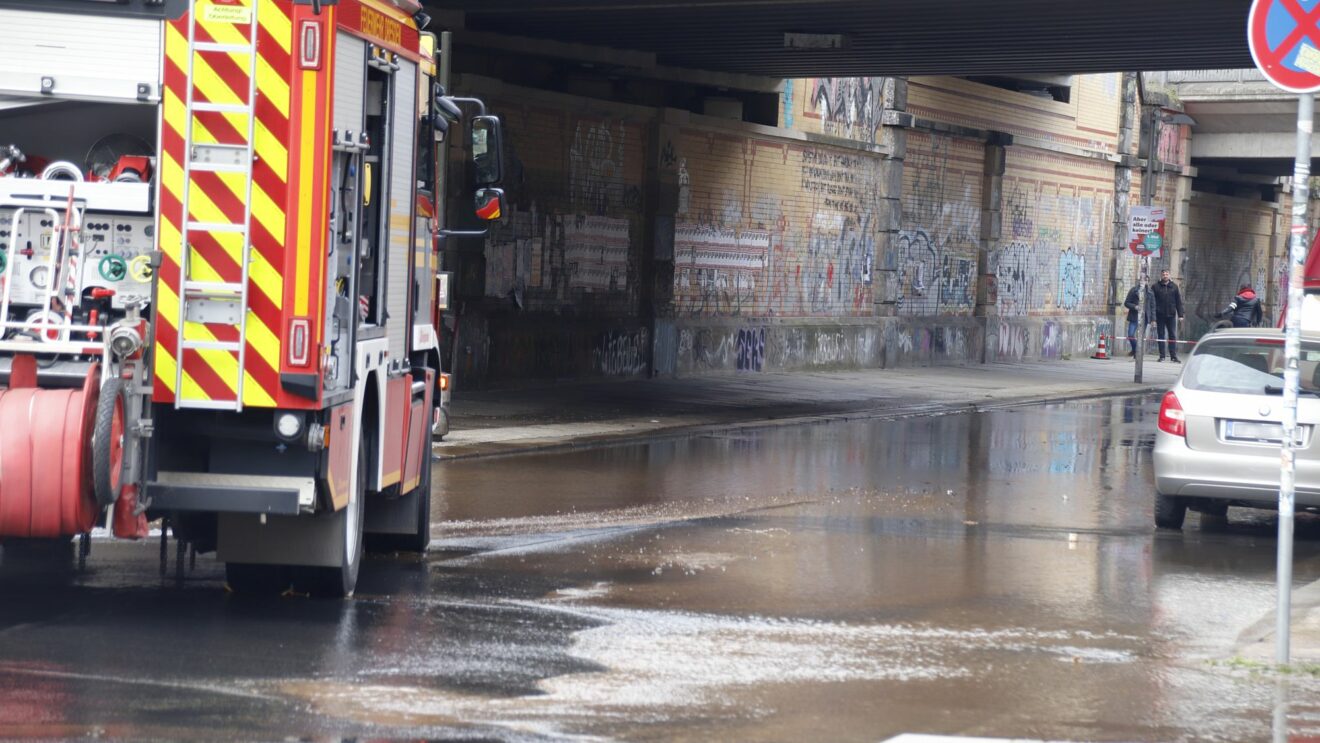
left=436, top=358, right=1181, bottom=459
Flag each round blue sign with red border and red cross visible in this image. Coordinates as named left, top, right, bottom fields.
left=1246, top=0, right=1320, bottom=92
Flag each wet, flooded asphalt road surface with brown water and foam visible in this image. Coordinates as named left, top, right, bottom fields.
left=0, top=397, right=1320, bottom=740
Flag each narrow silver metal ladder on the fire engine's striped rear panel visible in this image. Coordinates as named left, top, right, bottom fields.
left=174, top=0, right=260, bottom=412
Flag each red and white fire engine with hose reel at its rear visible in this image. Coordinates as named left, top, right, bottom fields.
left=0, top=0, right=503, bottom=597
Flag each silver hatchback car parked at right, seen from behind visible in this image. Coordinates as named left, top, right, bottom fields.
left=1155, top=329, right=1320, bottom=529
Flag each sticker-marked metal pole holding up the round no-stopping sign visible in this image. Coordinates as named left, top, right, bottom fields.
left=1274, top=92, right=1316, bottom=665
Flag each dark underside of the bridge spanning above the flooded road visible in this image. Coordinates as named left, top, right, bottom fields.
left=426, top=0, right=1251, bottom=78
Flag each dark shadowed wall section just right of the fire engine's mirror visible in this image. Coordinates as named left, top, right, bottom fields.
left=484, top=96, right=653, bottom=317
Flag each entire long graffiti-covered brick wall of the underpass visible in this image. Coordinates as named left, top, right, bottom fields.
left=451, top=68, right=1320, bottom=383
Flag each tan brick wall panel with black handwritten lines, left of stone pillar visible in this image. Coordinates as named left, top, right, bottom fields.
left=664, top=125, right=883, bottom=318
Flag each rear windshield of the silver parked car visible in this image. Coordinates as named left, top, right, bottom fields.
left=1183, top=338, right=1320, bottom=395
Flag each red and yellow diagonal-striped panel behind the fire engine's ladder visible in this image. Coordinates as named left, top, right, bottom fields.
left=156, top=0, right=293, bottom=406
